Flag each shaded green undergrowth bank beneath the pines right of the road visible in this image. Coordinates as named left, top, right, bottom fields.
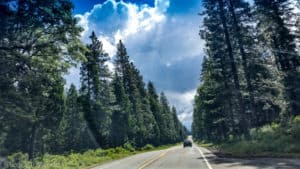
left=199, top=116, right=300, bottom=158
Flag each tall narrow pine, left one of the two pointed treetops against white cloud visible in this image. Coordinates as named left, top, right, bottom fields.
left=81, top=32, right=112, bottom=146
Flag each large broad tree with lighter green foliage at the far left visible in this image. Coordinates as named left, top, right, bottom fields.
left=0, top=0, right=83, bottom=159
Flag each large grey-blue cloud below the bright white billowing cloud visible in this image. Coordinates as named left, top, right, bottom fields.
left=126, top=13, right=202, bottom=92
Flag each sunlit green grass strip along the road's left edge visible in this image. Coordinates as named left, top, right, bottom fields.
left=0, top=144, right=175, bottom=169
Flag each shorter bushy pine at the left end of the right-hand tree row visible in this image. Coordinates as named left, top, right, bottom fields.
left=193, top=56, right=230, bottom=141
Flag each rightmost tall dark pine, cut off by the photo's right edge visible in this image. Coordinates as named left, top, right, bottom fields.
left=255, top=0, right=300, bottom=116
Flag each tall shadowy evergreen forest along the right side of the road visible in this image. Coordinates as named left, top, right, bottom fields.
left=192, top=0, right=300, bottom=146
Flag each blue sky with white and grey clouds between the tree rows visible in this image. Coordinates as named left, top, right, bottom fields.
left=66, top=0, right=204, bottom=129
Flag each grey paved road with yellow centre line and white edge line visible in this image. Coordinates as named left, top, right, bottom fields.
left=93, top=146, right=300, bottom=169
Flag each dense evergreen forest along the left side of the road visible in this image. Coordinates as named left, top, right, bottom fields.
left=0, top=0, right=187, bottom=160
